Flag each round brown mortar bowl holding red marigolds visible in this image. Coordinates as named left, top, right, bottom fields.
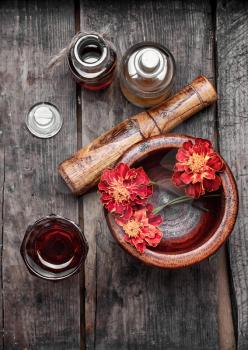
left=106, top=135, right=238, bottom=269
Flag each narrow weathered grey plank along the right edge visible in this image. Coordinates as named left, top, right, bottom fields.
left=217, top=1, right=248, bottom=350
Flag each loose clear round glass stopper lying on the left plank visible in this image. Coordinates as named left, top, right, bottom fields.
left=26, top=102, right=63, bottom=138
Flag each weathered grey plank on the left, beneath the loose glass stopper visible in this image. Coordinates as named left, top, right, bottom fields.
left=0, top=1, right=80, bottom=350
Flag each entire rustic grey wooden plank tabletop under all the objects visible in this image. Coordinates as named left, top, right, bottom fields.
left=0, top=0, right=248, bottom=350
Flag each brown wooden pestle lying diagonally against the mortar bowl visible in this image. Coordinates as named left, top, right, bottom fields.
left=59, top=76, right=217, bottom=195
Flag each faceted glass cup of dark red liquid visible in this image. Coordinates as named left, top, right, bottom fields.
left=21, top=214, right=88, bottom=280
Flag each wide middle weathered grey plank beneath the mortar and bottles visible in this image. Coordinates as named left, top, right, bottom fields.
left=81, top=0, right=218, bottom=350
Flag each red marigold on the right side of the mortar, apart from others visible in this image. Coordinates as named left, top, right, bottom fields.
left=172, top=138, right=224, bottom=198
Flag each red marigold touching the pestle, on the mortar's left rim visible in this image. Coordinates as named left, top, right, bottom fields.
left=98, top=163, right=152, bottom=219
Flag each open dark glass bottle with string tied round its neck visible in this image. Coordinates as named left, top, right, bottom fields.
left=68, top=34, right=116, bottom=91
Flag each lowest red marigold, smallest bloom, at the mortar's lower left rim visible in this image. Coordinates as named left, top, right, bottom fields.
left=115, top=204, right=163, bottom=253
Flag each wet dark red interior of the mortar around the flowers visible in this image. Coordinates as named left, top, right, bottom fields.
left=133, top=149, right=224, bottom=254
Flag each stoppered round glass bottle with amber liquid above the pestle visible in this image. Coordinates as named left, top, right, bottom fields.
left=120, top=41, right=176, bottom=107
